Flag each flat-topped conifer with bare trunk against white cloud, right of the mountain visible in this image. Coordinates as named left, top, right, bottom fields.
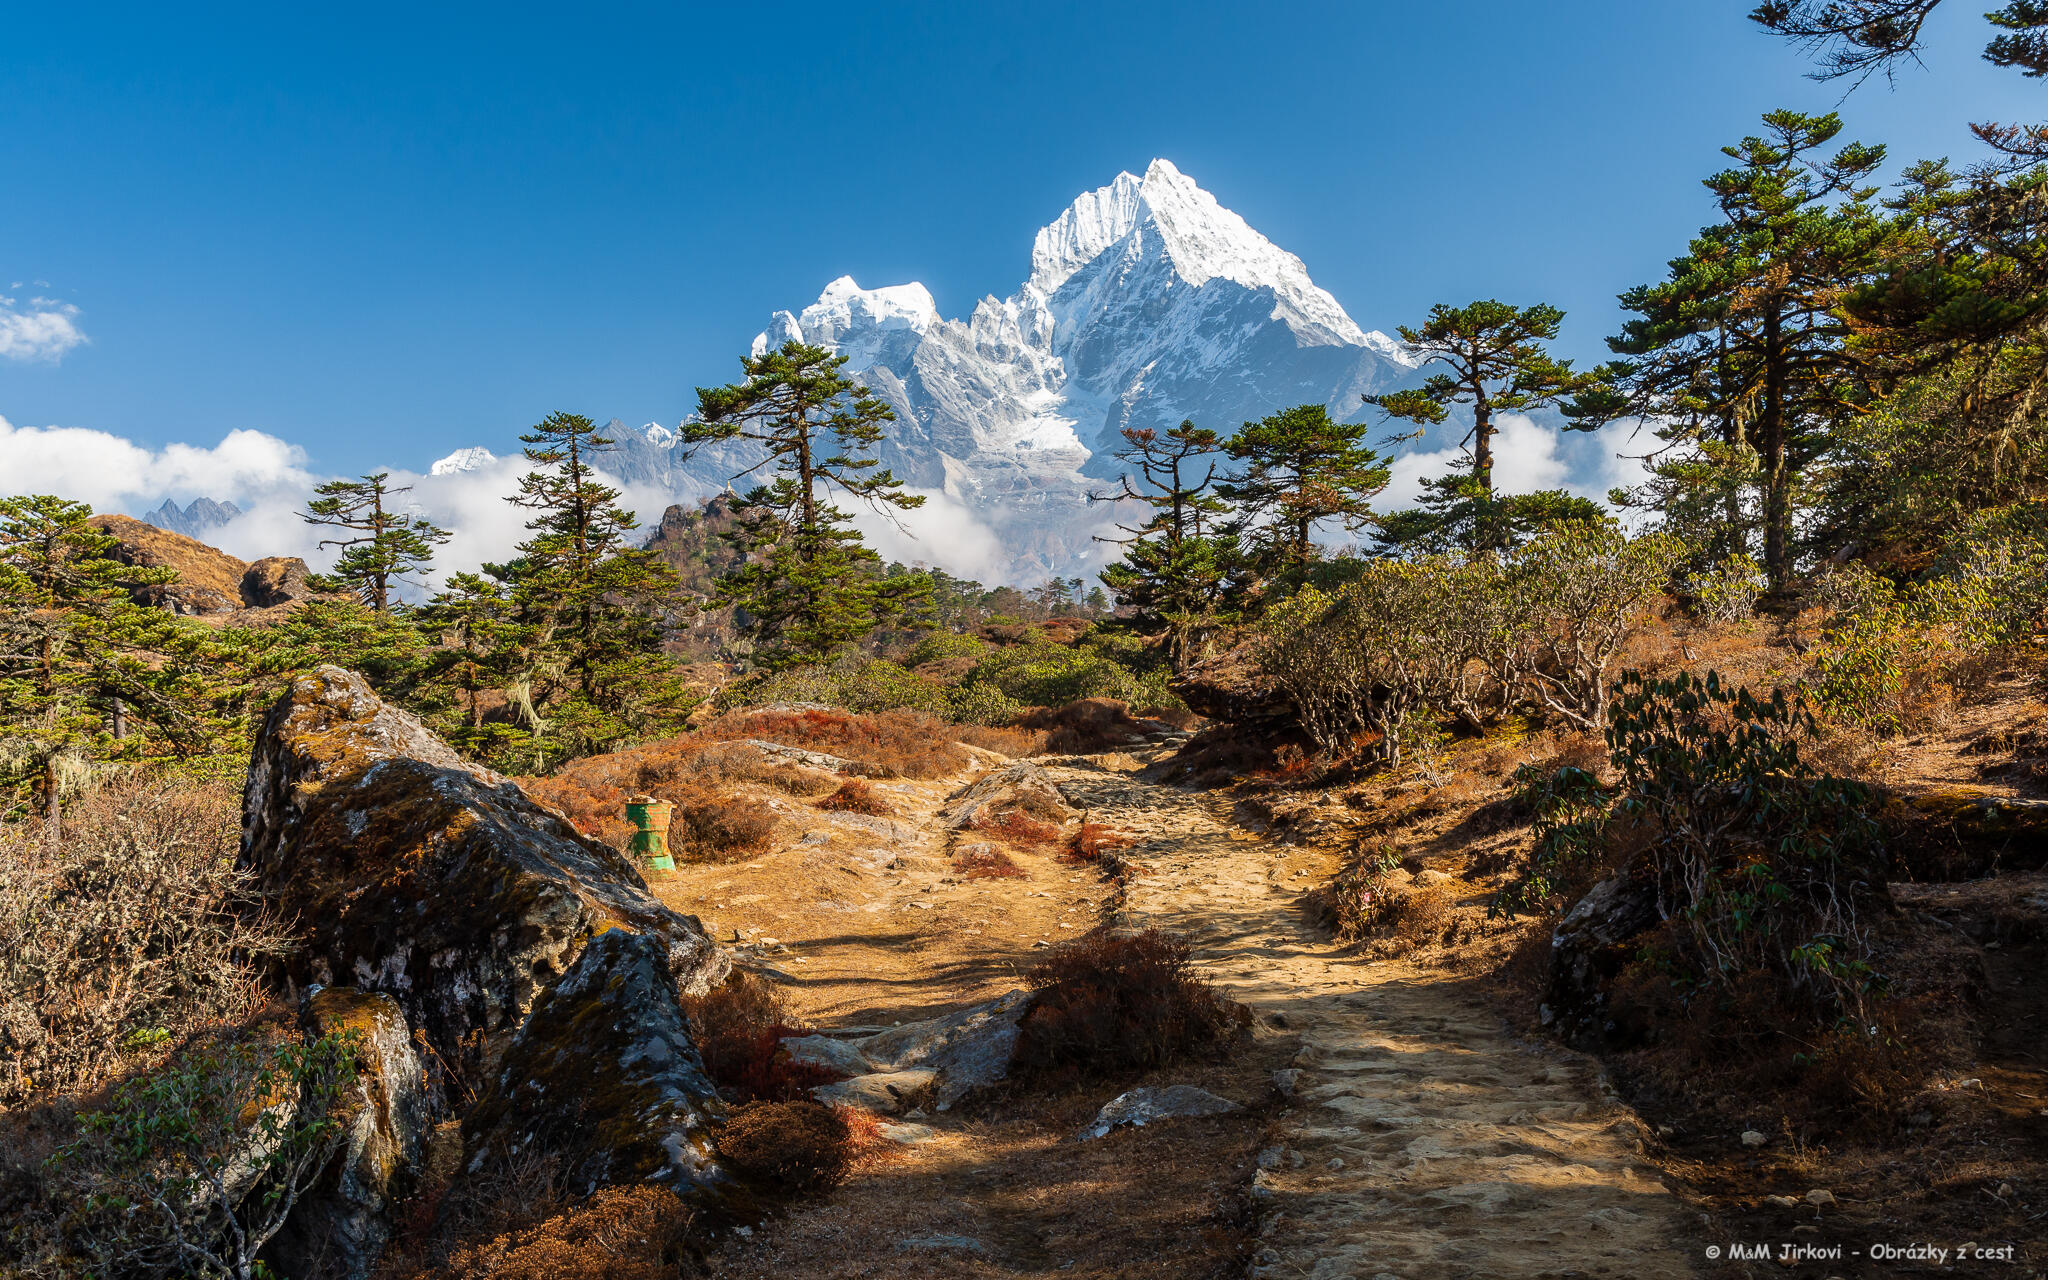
left=1364, top=299, right=1599, bottom=551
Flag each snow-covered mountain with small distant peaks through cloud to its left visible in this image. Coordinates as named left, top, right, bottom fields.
left=450, top=160, right=1417, bottom=582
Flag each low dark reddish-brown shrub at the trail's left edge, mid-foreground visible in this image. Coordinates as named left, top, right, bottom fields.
left=1014, top=930, right=1251, bottom=1075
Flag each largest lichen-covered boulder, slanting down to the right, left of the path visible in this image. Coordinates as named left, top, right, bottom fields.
left=242, top=666, right=731, bottom=1071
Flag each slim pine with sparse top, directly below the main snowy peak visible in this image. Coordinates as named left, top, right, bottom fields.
left=1090, top=422, right=1237, bottom=674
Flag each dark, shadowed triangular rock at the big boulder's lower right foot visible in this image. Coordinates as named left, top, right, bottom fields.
left=463, top=930, right=731, bottom=1198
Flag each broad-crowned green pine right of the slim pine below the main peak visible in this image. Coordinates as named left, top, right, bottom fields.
left=1217, top=403, right=1391, bottom=578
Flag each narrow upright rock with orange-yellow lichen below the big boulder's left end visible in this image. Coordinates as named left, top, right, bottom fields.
left=266, top=987, right=434, bottom=1280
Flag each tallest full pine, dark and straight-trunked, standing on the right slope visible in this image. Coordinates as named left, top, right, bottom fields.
left=1571, top=111, right=1898, bottom=590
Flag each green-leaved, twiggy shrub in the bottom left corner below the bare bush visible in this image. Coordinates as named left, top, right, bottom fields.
left=49, top=1032, right=358, bottom=1280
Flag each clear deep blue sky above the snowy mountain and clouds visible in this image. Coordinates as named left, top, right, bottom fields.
left=0, top=0, right=2048, bottom=479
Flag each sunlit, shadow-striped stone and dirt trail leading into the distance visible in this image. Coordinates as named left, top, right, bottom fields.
left=1053, top=762, right=1704, bottom=1280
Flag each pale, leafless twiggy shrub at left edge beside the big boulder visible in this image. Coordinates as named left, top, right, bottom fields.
left=0, top=772, right=289, bottom=1104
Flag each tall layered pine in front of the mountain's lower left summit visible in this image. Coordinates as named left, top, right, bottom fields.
left=682, top=340, right=930, bottom=670
